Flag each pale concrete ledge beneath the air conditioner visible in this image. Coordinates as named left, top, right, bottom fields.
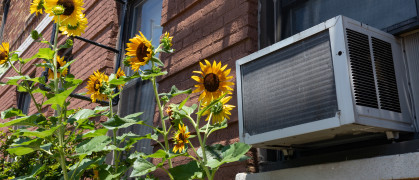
left=236, top=152, right=419, bottom=180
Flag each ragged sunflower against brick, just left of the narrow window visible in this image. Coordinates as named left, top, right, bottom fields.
left=86, top=70, right=109, bottom=102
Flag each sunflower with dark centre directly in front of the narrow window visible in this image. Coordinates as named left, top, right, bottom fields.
left=126, top=32, right=153, bottom=71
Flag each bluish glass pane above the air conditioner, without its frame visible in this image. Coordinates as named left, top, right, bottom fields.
left=282, top=0, right=417, bottom=37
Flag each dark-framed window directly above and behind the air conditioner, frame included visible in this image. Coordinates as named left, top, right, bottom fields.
left=259, top=0, right=419, bottom=48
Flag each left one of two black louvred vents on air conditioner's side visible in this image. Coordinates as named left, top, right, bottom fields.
left=346, top=29, right=380, bottom=108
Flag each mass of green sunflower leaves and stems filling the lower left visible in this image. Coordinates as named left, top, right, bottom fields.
left=0, top=14, right=250, bottom=180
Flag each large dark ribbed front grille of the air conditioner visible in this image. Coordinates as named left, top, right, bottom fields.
left=241, top=31, right=338, bottom=135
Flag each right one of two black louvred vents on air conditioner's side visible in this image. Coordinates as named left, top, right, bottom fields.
left=371, top=37, right=401, bottom=112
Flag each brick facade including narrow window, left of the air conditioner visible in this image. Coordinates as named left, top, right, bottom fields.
left=0, top=0, right=258, bottom=179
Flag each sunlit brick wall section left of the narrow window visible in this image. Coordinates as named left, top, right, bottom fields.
left=0, top=0, right=119, bottom=125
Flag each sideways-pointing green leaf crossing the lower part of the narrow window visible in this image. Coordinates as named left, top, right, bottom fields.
left=102, top=112, right=144, bottom=129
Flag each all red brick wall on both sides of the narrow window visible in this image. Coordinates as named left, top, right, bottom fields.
left=0, top=0, right=257, bottom=179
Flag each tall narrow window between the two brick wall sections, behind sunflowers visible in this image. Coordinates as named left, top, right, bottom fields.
left=119, top=0, right=163, bottom=153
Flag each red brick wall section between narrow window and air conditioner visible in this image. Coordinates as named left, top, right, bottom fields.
left=155, top=0, right=257, bottom=179
